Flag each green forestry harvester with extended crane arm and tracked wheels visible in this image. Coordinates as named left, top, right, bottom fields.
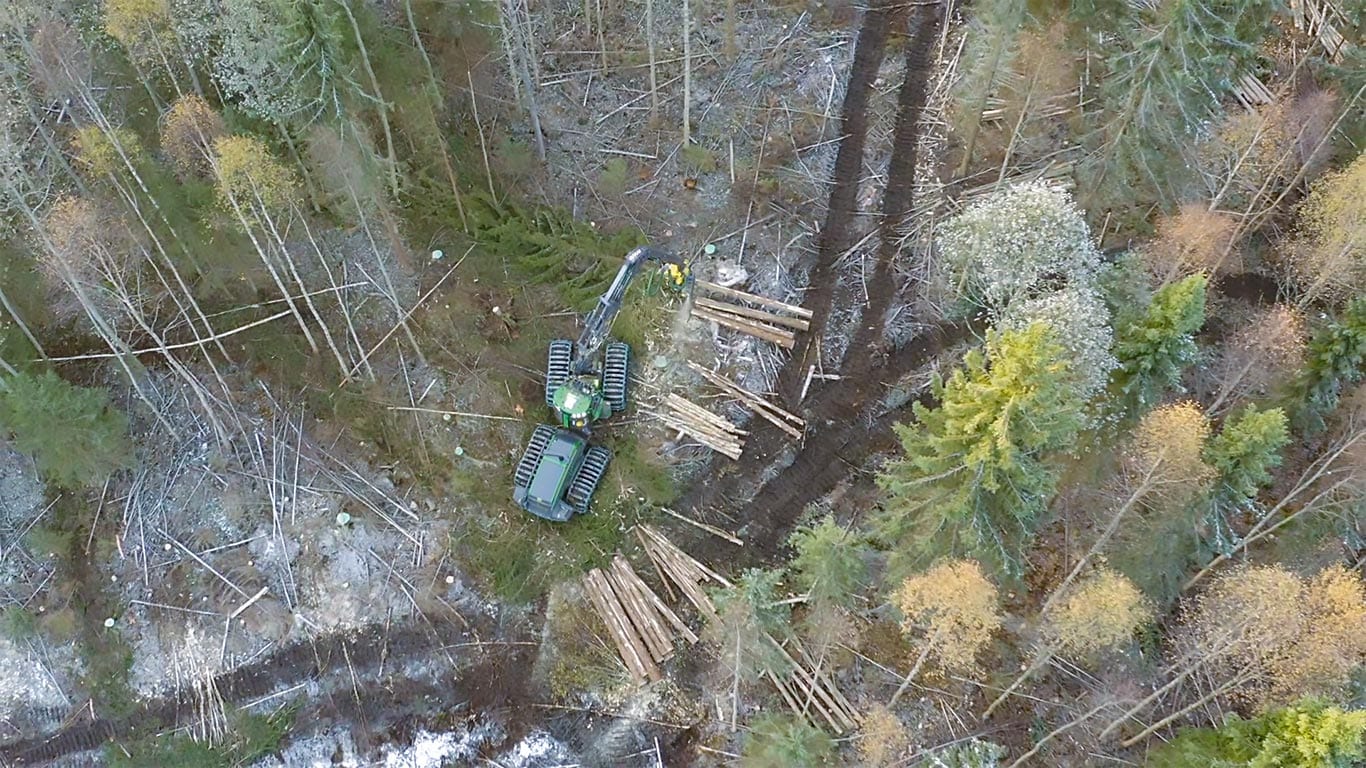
left=512, top=246, right=688, bottom=522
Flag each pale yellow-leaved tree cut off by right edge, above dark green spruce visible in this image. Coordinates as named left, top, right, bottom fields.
left=1291, top=152, right=1366, bottom=306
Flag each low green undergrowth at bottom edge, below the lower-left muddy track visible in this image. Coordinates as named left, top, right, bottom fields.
left=105, top=708, right=295, bottom=768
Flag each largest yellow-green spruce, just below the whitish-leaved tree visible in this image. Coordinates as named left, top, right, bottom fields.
left=877, top=323, right=1085, bottom=571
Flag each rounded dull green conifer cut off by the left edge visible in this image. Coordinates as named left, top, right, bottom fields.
left=0, top=370, right=133, bottom=488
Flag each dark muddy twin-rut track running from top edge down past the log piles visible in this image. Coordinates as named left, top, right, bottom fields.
left=683, top=4, right=950, bottom=560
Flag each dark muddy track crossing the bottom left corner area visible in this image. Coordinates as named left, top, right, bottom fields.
left=0, top=614, right=534, bottom=768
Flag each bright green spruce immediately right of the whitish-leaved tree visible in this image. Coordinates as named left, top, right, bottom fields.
left=1111, top=275, right=1208, bottom=417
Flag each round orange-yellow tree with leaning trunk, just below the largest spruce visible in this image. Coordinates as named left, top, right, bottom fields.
left=888, top=552, right=1001, bottom=707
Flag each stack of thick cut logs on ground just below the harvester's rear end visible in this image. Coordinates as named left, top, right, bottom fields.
left=583, top=555, right=698, bottom=685
